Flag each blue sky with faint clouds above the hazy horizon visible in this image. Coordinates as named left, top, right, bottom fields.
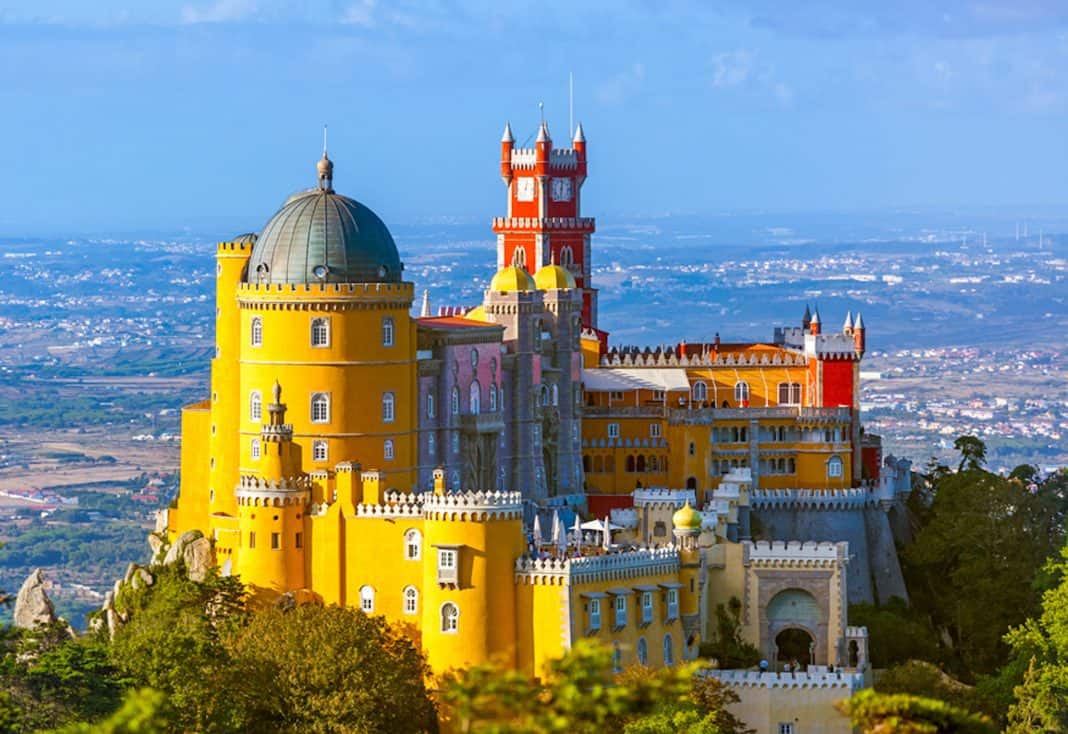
left=0, top=0, right=1068, bottom=236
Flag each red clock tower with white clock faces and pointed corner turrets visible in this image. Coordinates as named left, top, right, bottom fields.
left=493, top=121, right=597, bottom=329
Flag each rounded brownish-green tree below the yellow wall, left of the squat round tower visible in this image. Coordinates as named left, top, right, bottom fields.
left=224, top=605, right=437, bottom=734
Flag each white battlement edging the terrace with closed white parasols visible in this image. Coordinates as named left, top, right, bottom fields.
left=516, top=546, right=679, bottom=584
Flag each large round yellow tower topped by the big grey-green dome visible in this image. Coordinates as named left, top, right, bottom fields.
left=235, top=154, right=418, bottom=490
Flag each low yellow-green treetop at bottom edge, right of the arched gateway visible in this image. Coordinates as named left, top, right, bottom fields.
left=838, top=688, right=998, bottom=734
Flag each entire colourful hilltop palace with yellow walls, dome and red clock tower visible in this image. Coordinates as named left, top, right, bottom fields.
left=160, top=123, right=909, bottom=732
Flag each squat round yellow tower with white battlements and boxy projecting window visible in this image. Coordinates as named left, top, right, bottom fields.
left=422, top=491, right=527, bottom=670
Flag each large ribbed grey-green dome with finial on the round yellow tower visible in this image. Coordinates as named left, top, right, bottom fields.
left=248, top=157, right=403, bottom=285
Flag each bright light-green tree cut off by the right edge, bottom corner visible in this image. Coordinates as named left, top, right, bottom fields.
left=1006, top=547, right=1068, bottom=734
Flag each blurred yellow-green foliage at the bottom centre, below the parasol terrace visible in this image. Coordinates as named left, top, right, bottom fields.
left=442, top=640, right=698, bottom=734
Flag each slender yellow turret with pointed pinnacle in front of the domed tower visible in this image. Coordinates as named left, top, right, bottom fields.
left=234, top=381, right=311, bottom=598
